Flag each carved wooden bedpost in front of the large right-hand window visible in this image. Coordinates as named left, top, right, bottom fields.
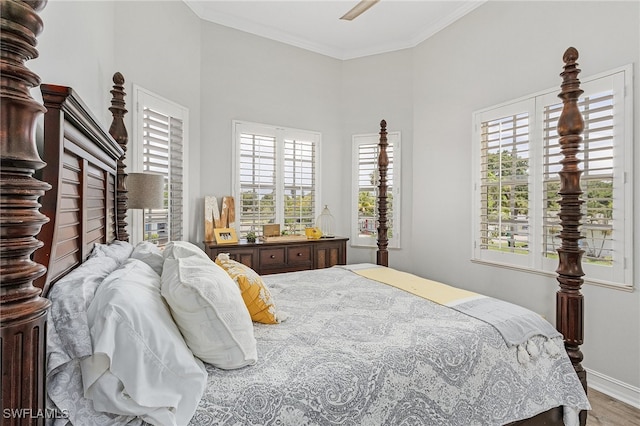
left=556, top=47, right=587, bottom=412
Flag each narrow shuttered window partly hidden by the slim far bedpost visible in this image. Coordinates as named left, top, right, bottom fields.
left=351, top=132, right=401, bottom=248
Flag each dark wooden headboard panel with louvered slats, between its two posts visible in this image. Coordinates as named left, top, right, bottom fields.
left=34, top=84, right=124, bottom=294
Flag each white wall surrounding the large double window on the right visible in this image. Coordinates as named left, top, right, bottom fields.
left=411, top=2, right=640, bottom=405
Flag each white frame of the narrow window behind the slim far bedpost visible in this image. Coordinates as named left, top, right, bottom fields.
left=350, top=131, right=402, bottom=249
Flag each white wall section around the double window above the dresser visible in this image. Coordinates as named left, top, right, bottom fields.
left=198, top=22, right=348, bottom=241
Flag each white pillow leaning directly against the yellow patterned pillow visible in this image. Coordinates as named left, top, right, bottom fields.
left=162, top=256, right=258, bottom=369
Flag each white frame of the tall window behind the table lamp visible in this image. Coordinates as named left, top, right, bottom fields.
left=128, top=84, right=190, bottom=244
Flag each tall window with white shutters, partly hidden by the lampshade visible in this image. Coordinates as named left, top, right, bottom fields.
left=130, top=86, right=189, bottom=246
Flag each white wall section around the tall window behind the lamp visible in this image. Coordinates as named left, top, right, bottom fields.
left=114, top=1, right=204, bottom=242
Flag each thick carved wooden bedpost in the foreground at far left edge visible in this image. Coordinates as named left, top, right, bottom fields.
left=0, top=0, right=51, bottom=425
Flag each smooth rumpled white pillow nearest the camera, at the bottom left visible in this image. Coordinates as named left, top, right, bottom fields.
left=81, top=259, right=207, bottom=425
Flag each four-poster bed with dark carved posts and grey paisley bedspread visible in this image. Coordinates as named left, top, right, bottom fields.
left=0, top=1, right=589, bottom=425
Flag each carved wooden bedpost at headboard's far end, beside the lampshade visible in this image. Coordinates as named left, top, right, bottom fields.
left=109, top=72, right=129, bottom=241
